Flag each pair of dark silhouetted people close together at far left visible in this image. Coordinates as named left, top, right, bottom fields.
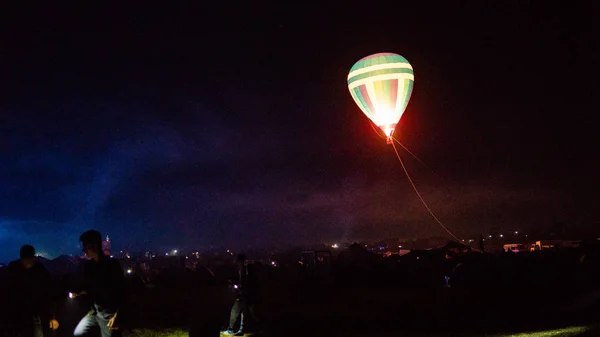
left=0, top=230, right=127, bottom=337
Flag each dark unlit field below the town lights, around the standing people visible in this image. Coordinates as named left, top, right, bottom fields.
left=5, top=244, right=600, bottom=337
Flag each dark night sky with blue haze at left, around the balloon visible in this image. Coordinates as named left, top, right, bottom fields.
left=0, top=1, right=600, bottom=261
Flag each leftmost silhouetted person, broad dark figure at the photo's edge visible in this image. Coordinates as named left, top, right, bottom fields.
left=6, top=245, right=58, bottom=337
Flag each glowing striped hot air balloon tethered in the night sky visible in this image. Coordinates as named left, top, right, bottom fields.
left=348, top=53, right=415, bottom=144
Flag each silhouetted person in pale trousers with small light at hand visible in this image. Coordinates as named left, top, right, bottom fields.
left=73, top=230, right=126, bottom=337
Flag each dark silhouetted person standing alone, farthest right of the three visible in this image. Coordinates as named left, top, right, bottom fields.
left=224, top=254, right=258, bottom=336
